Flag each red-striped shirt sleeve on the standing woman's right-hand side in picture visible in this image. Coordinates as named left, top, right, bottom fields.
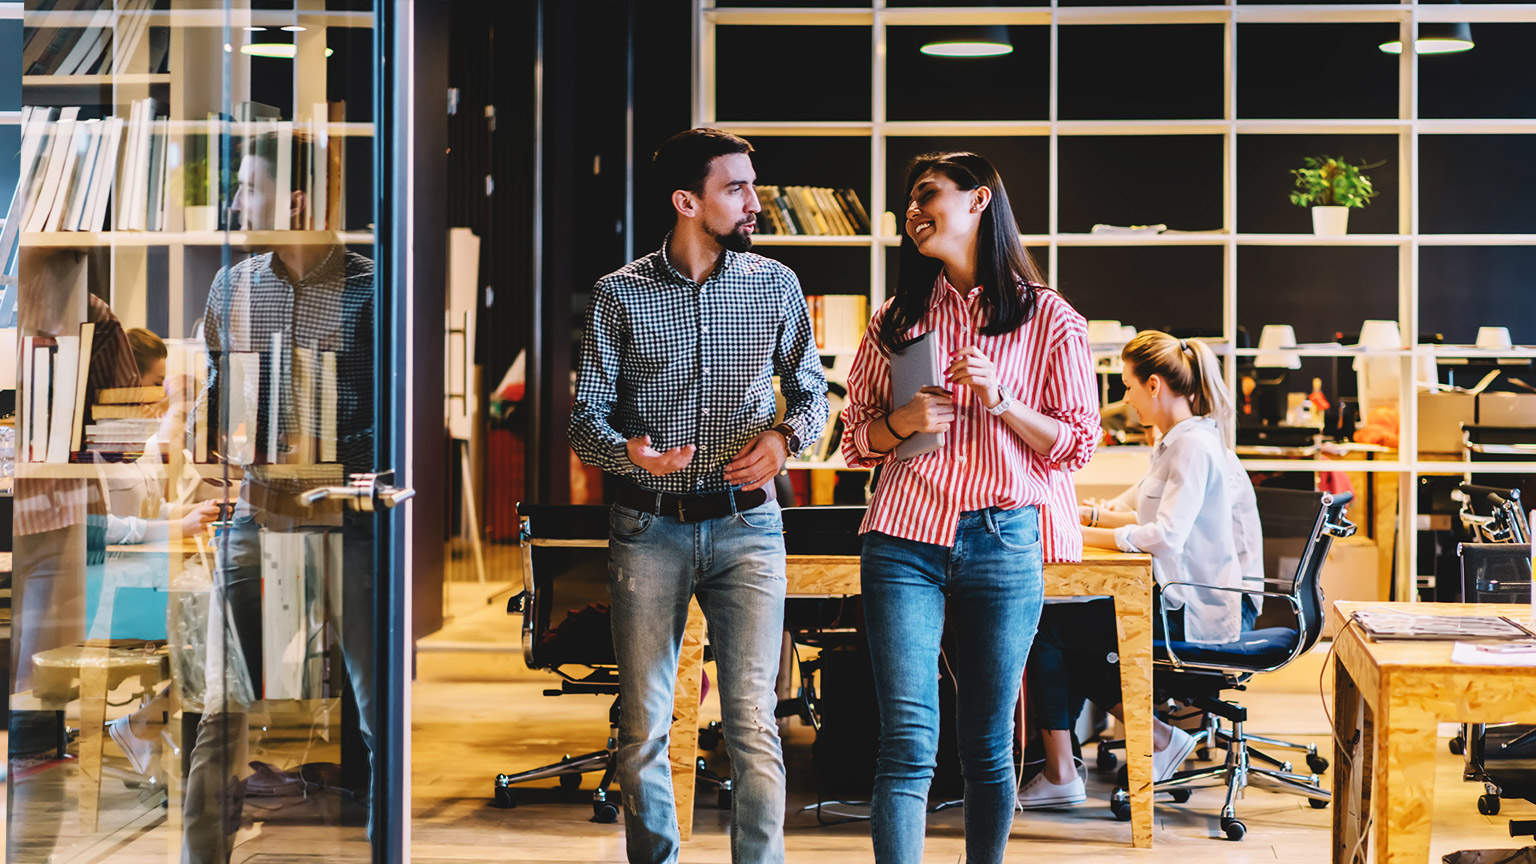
left=1040, top=307, right=1100, bottom=470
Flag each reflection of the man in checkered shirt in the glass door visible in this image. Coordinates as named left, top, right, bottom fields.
left=183, top=132, right=373, bottom=864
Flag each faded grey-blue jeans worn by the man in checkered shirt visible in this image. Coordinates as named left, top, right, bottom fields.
left=608, top=501, right=785, bottom=864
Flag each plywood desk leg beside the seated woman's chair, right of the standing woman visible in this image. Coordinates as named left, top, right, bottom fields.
left=1115, top=581, right=1152, bottom=849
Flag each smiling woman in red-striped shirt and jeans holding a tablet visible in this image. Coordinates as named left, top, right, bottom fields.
left=842, top=152, right=1098, bottom=864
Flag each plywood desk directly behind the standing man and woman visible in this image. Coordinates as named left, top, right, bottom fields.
left=670, top=549, right=1152, bottom=849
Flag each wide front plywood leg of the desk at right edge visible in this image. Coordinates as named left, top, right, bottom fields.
left=1372, top=693, right=1436, bottom=864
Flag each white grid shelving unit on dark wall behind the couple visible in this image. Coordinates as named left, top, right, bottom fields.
left=693, top=0, right=1536, bottom=596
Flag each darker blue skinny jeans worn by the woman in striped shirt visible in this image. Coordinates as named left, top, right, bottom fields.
left=860, top=507, right=1044, bottom=864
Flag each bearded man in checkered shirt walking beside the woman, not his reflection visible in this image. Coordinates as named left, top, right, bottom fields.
left=570, top=129, right=826, bottom=864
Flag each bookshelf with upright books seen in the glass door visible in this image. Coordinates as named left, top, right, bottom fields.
left=12, top=0, right=375, bottom=478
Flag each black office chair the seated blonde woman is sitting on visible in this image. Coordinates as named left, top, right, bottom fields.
left=1100, top=489, right=1355, bottom=839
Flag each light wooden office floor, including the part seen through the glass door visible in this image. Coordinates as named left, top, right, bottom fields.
left=8, top=559, right=1536, bottom=864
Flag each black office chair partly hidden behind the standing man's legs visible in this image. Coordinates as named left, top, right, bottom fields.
left=493, top=504, right=731, bottom=822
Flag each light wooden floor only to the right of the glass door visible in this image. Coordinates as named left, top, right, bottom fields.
left=412, top=596, right=1536, bottom=864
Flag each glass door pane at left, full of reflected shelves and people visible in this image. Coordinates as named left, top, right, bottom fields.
left=0, top=0, right=390, bottom=862
